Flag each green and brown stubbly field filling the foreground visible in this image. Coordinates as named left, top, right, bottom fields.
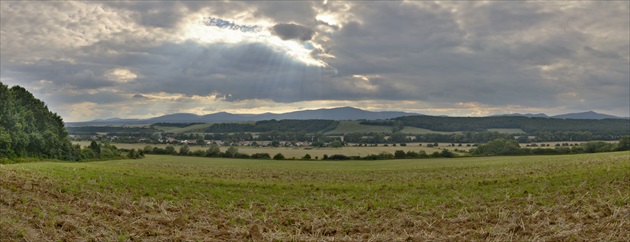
left=0, top=152, right=630, bottom=241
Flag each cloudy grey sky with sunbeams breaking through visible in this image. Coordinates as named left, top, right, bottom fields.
left=0, top=0, right=630, bottom=122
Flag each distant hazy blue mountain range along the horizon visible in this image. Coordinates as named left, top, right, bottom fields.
left=66, top=107, right=620, bottom=126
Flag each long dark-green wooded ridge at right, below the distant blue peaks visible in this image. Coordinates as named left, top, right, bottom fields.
left=362, top=116, right=630, bottom=136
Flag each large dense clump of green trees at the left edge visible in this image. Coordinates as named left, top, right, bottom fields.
left=0, top=83, right=75, bottom=160
